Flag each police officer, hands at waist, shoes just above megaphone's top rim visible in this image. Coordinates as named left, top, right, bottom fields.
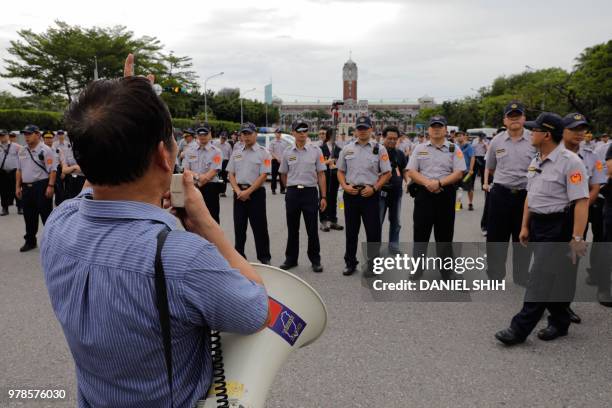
left=227, top=122, right=272, bottom=265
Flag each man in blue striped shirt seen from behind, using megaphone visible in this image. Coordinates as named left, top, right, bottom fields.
left=41, top=56, right=268, bottom=408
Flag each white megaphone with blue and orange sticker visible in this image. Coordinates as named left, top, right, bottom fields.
left=197, top=264, right=327, bottom=408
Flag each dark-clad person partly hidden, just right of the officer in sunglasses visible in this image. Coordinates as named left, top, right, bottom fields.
left=319, top=127, right=344, bottom=232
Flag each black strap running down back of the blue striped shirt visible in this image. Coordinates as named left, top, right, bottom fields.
left=155, top=227, right=174, bottom=407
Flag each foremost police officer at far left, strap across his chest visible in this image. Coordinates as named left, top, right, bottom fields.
left=15, top=125, right=57, bottom=252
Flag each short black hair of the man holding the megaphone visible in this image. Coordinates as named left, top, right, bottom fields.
left=64, top=77, right=173, bottom=186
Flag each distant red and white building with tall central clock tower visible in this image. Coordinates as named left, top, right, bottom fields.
left=275, top=58, right=436, bottom=135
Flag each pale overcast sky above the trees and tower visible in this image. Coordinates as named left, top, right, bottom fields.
left=0, top=0, right=612, bottom=101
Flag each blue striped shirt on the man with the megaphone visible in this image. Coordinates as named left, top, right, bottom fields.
left=41, top=190, right=267, bottom=408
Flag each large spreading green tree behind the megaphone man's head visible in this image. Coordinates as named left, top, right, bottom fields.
left=1, top=21, right=193, bottom=102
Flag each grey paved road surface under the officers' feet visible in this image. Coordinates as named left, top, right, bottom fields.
left=0, top=188, right=612, bottom=408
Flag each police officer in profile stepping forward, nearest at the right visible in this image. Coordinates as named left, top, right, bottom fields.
left=495, top=112, right=589, bottom=345
